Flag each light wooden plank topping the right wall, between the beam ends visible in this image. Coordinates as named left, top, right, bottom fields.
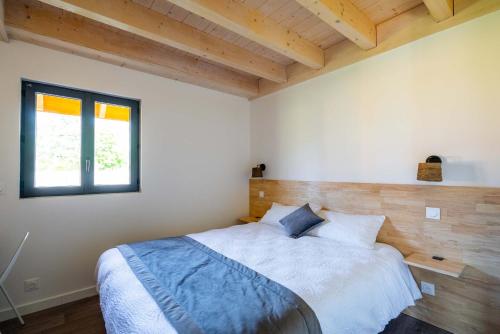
left=258, top=0, right=500, bottom=97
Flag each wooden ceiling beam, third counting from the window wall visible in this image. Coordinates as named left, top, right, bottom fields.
left=169, top=0, right=324, bottom=69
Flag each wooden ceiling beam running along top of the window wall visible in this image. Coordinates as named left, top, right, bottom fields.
left=5, top=0, right=258, bottom=97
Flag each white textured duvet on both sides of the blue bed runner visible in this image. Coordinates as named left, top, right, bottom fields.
left=97, top=223, right=421, bottom=334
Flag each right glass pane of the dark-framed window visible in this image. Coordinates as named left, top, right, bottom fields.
left=94, top=102, right=130, bottom=185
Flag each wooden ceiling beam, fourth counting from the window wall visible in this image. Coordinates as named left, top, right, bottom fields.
left=296, top=0, right=377, bottom=50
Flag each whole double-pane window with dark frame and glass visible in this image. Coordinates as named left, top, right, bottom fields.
left=20, top=81, right=140, bottom=198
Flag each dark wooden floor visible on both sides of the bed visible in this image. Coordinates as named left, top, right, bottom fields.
left=0, top=296, right=449, bottom=334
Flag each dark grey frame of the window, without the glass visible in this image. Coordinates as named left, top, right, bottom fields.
left=20, top=80, right=140, bottom=198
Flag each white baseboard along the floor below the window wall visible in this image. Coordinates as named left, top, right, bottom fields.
left=0, top=285, right=97, bottom=321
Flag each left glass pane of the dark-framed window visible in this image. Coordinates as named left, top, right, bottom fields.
left=35, top=93, right=82, bottom=187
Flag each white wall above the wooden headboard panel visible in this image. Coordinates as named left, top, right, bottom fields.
left=250, top=12, right=500, bottom=186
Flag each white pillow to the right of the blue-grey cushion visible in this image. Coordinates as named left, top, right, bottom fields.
left=307, top=211, right=385, bottom=249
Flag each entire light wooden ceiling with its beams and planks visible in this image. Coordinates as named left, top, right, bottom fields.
left=0, top=0, right=500, bottom=98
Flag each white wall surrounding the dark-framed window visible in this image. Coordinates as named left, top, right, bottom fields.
left=0, top=41, right=250, bottom=309
